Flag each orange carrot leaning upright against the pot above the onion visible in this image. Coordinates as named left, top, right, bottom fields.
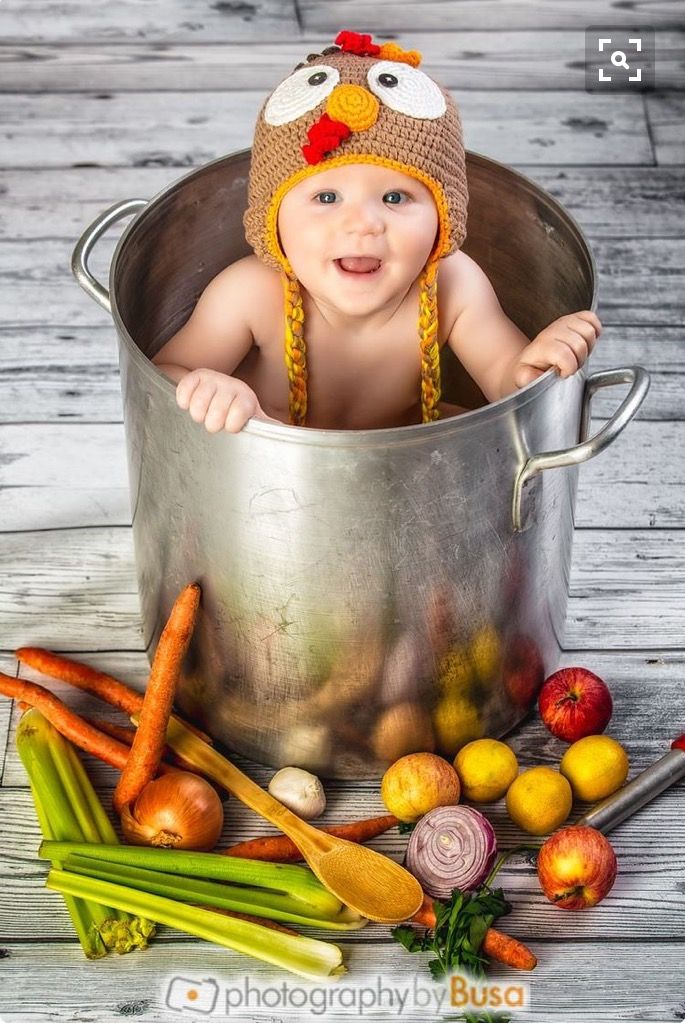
left=113, top=583, right=200, bottom=813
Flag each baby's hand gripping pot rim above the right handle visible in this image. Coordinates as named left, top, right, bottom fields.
left=513, top=309, right=602, bottom=387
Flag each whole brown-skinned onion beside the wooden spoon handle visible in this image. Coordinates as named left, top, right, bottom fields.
left=122, top=770, right=224, bottom=851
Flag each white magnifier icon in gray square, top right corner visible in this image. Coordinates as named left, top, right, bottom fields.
left=585, top=26, right=654, bottom=92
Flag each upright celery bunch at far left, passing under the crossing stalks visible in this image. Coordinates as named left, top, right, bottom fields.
left=16, top=709, right=154, bottom=959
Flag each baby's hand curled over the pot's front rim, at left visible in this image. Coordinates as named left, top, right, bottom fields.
left=176, top=369, right=277, bottom=434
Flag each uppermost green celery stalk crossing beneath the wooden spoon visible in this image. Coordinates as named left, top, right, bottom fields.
left=38, top=842, right=343, bottom=919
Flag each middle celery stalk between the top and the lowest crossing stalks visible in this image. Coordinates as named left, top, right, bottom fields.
left=63, top=855, right=368, bottom=931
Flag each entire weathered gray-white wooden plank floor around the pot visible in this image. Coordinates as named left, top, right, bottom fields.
left=0, top=0, right=685, bottom=1023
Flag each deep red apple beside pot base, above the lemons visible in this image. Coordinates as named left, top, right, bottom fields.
left=538, top=668, right=613, bottom=743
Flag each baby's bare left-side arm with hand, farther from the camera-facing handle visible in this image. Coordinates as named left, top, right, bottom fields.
left=152, top=259, right=276, bottom=434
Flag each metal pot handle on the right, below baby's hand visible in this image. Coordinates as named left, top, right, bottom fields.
left=512, top=366, right=649, bottom=532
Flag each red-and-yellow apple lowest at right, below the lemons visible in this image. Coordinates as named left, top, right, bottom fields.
left=538, top=825, right=617, bottom=909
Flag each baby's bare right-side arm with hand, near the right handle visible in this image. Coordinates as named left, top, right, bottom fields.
left=448, top=253, right=601, bottom=401
